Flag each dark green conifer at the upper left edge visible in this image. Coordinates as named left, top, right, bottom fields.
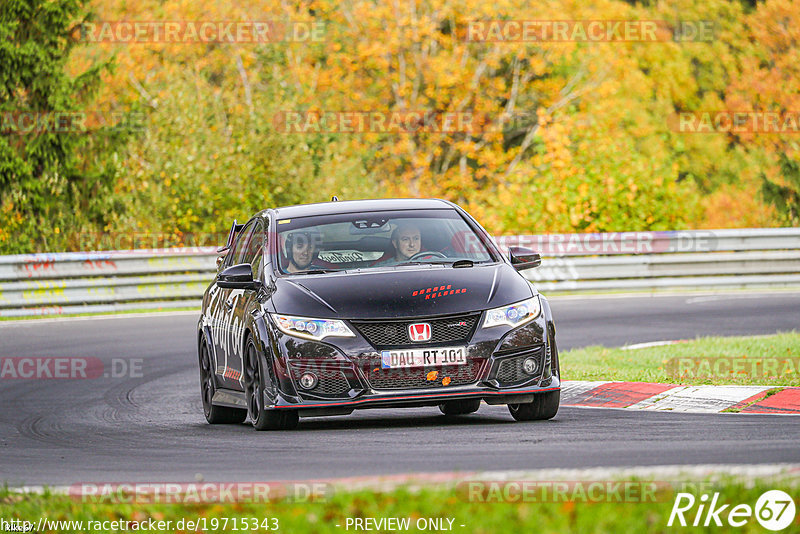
left=0, top=0, right=120, bottom=253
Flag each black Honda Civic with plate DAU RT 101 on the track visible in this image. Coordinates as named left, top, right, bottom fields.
left=197, top=199, right=561, bottom=430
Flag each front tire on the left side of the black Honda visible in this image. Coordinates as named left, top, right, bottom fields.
left=244, top=337, right=300, bottom=430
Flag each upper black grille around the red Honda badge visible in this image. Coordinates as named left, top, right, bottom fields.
left=353, top=313, right=480, bottom=349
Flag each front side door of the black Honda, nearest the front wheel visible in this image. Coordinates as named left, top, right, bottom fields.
left=228, top=221, right=265, bottom=391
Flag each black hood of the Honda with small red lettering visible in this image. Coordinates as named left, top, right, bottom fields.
left=272, top=263, right=534, bottom=319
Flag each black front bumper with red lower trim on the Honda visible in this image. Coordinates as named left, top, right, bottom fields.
left=265, top=315, right=561, bottom=416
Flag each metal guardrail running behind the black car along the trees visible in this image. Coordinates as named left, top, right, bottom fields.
left=0, top=228, right=800, bottom=316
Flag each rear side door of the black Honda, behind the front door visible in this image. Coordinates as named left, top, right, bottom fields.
left=215, top=221, right=256, bottom=389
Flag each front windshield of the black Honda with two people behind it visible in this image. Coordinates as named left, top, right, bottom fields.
left=277, top=209, right=494, bottom=274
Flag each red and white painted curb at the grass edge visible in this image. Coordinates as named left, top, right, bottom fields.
left=561, top=381, right=800, bottom=414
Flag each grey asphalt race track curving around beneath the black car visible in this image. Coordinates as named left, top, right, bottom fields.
left=0, top=292, right=800, bottom=485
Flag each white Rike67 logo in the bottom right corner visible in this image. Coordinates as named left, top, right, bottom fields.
left=667, top=490, right=796, bottom=531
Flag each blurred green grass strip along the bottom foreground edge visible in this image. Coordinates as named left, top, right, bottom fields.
left=0, top=479, right=800, bottom=534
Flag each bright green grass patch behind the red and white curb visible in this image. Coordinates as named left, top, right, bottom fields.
left=559, top=332, right=800, bottom=386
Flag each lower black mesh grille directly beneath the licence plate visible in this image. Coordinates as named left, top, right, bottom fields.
left=367, top=359, right=485, bottom=389
